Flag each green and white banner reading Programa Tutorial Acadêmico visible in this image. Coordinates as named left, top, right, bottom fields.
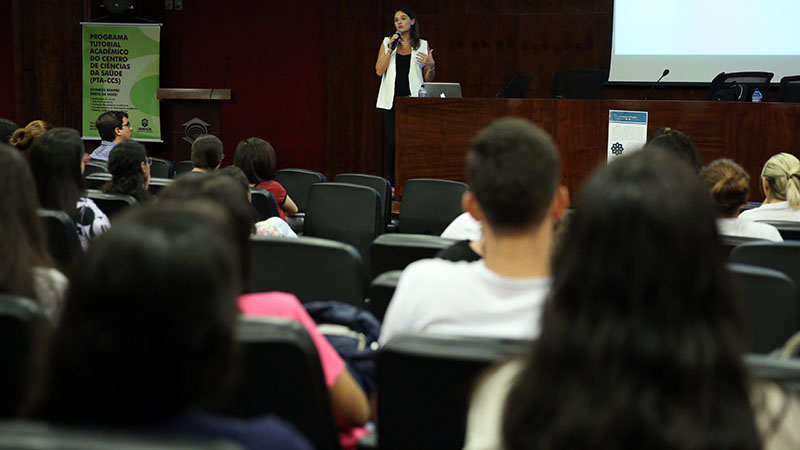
left=81, top=22, right=161, bottom=142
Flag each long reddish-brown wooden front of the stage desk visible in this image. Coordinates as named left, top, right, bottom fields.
left=395, top=98, right=800, bottom=201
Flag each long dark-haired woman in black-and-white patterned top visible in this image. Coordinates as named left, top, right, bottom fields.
left=28, top=128, right=110, bottom=249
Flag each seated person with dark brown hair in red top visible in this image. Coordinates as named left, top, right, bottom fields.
left=233, top=137, right=297, bottom=220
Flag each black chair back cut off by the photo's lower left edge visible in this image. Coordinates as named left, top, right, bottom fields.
left=0, top=294, right=50, bottom=418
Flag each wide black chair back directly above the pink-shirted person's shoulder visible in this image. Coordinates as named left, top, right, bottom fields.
left=250, top=236, right=365, bottom=307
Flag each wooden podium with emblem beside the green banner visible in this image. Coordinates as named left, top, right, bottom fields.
left=156, top=88, right=231, bottom=163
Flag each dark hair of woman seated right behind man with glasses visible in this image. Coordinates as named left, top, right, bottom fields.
left=103, top=141, right=150, bottom=203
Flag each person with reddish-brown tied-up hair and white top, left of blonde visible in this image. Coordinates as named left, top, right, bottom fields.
left=700, top=159, right=783, bottom=241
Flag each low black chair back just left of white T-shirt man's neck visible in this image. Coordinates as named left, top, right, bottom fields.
left=369, top=233, right=457, bottom=278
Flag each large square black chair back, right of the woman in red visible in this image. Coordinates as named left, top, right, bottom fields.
left=303, top=183, right=383, bottom=267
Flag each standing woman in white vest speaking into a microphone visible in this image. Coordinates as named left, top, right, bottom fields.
left=375, top=8, right=436, bottom=184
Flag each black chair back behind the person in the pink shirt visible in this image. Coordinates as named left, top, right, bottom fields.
left=217, top=316, right=341, bottom=450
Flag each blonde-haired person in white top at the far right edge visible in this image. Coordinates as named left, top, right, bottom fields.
left=739, top=153, right=800, bottom=222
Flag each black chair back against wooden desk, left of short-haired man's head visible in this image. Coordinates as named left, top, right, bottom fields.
left=399, top=178, right=469, bottom=236
